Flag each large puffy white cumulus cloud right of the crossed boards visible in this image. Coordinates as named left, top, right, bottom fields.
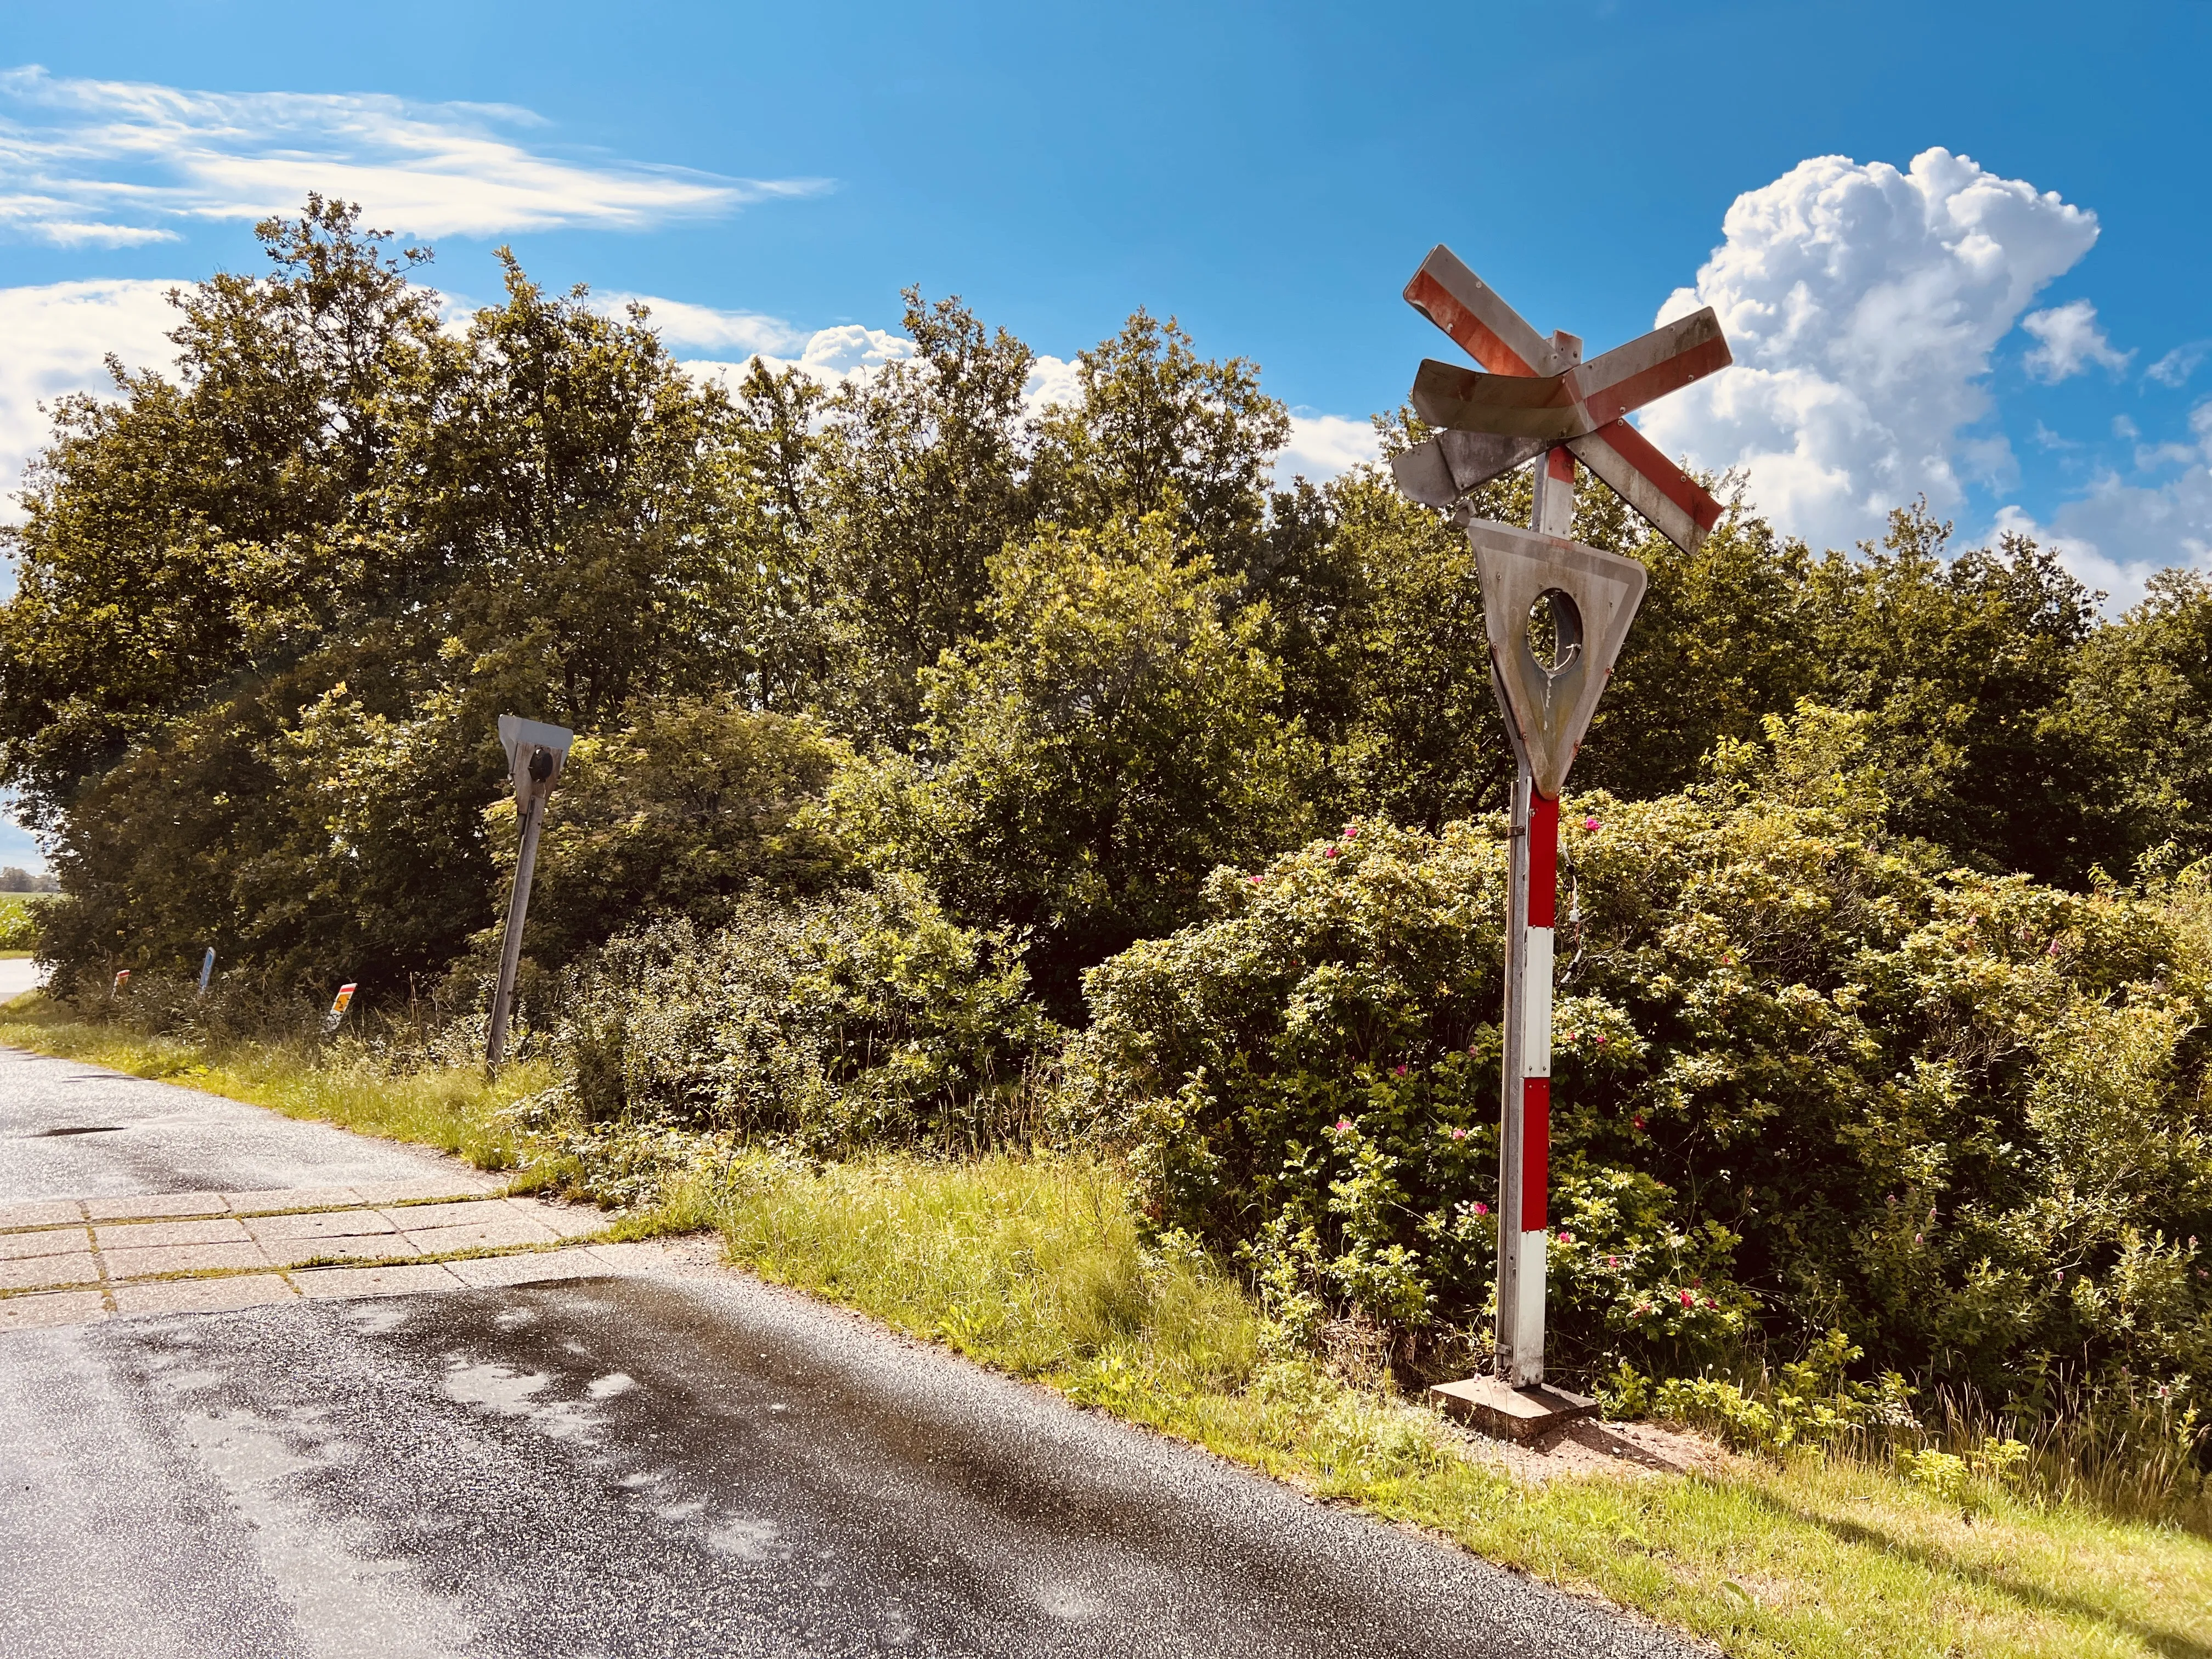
left=1644, top=148, right=2097, bottom=546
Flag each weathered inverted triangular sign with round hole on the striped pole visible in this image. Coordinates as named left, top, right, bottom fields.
left=1462, top=517, right=1650, bottom=801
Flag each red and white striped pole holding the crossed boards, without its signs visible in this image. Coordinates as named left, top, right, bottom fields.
left=1498, top=442, right=1579, bottom=1389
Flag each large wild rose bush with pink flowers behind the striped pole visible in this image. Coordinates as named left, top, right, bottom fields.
left=1070, top=708, right=2212, bottom=1413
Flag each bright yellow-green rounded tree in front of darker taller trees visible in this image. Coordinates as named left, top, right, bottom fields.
left=834, top=517, right=1312, bottom=1011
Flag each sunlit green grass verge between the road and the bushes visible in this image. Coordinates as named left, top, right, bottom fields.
left=0, top=1005, right=2212, bottom=1657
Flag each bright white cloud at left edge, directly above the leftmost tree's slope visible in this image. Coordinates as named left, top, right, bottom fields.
left=0, top=279, right=177, bottom=520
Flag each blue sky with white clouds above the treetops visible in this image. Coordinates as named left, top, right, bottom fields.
left=0, top=0, right=2212, bottom=858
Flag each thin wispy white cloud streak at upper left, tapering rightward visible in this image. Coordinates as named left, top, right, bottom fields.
left=0, top=66, right=827, bottom=246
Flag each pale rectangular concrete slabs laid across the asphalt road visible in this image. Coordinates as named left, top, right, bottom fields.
left=0, top=1175, right=657, bottom=1331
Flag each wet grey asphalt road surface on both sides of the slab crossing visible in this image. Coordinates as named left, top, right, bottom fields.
left=0, top=1055, right=1683, bottom=1659
